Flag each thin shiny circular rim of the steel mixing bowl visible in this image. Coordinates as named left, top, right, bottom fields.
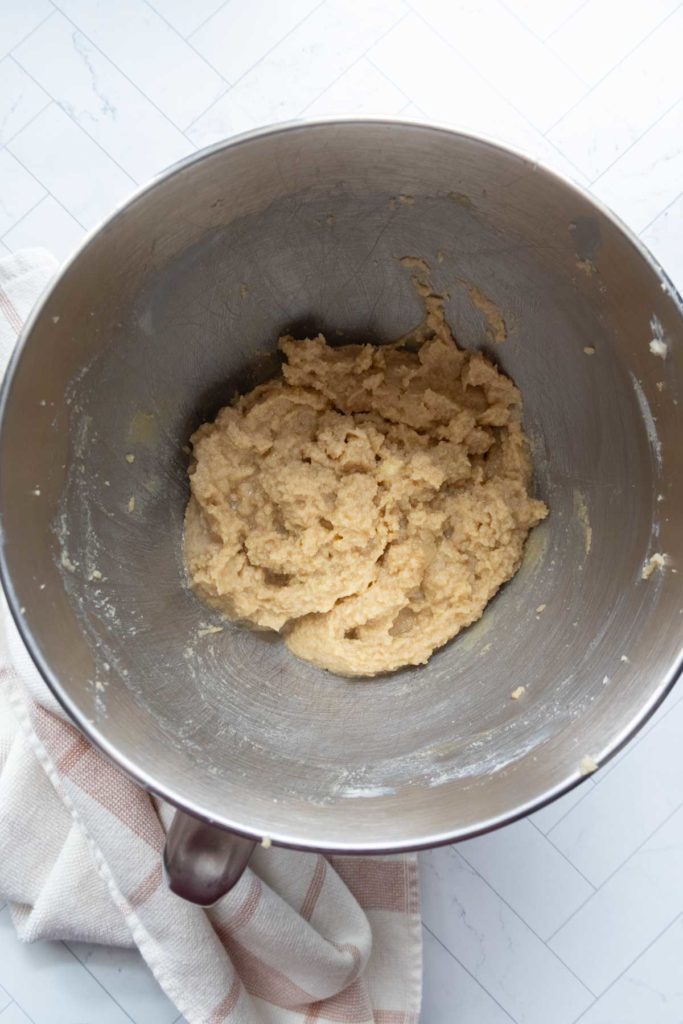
left=0, top=116, right=683, bottom=855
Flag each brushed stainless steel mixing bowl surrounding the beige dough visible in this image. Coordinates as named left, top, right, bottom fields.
left=0, top=121, right=683, bottom=901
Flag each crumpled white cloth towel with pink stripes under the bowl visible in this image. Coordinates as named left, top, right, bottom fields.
left=0, top=250, right=422, bottom=1024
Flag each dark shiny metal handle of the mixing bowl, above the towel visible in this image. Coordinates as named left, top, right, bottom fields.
left=164, top=811, right=256, bottom=906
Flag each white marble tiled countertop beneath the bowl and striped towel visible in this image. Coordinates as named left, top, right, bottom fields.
left=0, top=0, right=683, bottom=1024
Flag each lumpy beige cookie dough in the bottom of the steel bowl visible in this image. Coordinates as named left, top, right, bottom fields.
left=185, top=303, right=548, bottom=676
